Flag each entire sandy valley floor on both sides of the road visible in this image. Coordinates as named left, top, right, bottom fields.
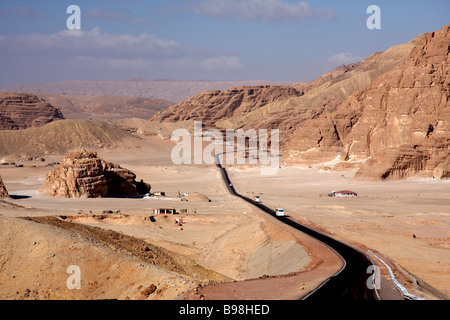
left=0, top=137, right=450, bottom=299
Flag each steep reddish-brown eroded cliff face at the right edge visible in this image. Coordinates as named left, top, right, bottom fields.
left=287, top=26, right=450, bottom=180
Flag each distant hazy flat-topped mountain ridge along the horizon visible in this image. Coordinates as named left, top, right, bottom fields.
left=0, top=78, right=283, bottom=103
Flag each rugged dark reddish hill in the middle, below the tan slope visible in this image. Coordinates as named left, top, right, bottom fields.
left=153, top=86, right=303, bottom=126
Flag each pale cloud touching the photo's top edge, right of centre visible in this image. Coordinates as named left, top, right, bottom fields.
left=193, top=0, right=336, bottom=22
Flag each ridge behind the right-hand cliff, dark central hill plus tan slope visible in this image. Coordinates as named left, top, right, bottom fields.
left=153, top=30, right=422, bottom=148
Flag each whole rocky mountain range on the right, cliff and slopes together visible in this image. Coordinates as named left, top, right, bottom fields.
left=153, top=26, right=450, bottom=180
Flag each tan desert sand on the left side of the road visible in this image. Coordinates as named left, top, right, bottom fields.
left=0, top=137, right=336, bottom=299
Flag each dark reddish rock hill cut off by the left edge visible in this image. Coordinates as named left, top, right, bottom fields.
left=0, top=93, right=64, bottom=130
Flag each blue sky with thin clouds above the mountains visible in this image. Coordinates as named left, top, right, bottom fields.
left=0, top=0, right=450, bottom=88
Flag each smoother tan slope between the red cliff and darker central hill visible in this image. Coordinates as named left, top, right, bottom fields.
left=230, top=32, right=422, bottom=150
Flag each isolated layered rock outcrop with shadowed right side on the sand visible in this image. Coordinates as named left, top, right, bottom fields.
left=39, top=150, right=151, bottom=198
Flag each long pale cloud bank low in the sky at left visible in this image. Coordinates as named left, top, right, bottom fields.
left=0, top=28, right=243, bottom=73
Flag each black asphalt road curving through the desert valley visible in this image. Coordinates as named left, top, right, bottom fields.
left=216, top=155, right=379, bottom=301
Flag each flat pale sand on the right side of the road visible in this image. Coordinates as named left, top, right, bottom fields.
left=230, top=165, right=450, bottom=295
